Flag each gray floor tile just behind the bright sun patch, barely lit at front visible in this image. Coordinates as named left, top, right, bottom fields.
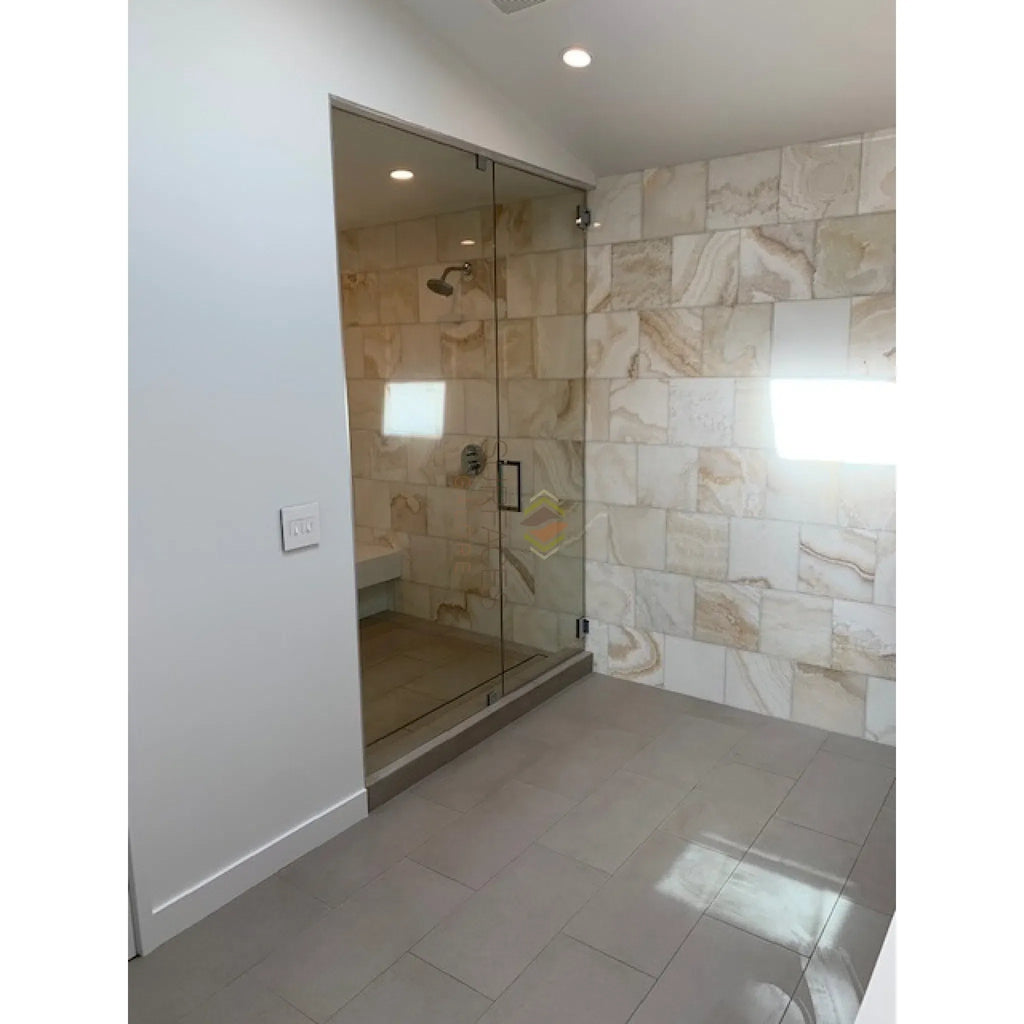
left=662, top=762, right=793, bottom=858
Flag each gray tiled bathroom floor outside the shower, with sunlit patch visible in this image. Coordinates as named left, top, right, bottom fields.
left=129, top=675, right=895, bottom=1024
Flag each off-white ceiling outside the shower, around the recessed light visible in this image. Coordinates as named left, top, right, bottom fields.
left=400, top=0, right=896, bottom=174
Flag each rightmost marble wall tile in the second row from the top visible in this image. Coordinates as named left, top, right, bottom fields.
left=814, top=213, right=896, bottom=299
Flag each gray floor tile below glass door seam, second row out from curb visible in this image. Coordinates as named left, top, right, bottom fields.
left=410, top=779, right=573, bottom=889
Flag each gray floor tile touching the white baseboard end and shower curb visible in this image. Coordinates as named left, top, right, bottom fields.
left=278, top=793, right=459, bottom=906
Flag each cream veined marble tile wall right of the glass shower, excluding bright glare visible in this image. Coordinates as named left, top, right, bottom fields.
left=587, top=130, right=896, bottom=742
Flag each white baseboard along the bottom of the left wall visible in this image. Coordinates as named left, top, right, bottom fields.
left=136, top=788, right=367, bottom=954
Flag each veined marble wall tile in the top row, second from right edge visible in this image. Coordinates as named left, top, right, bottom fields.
left=778, top=135, right=860, bottom=220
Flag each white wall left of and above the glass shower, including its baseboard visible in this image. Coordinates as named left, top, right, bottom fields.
left=129, top=0, right=591, bottom=952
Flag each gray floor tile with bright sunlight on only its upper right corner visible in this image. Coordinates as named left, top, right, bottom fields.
left=564, top=831, right=739, bottom=977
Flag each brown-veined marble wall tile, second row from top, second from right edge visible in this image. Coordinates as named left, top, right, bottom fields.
left=739, top=222, right=814, bottom=302
